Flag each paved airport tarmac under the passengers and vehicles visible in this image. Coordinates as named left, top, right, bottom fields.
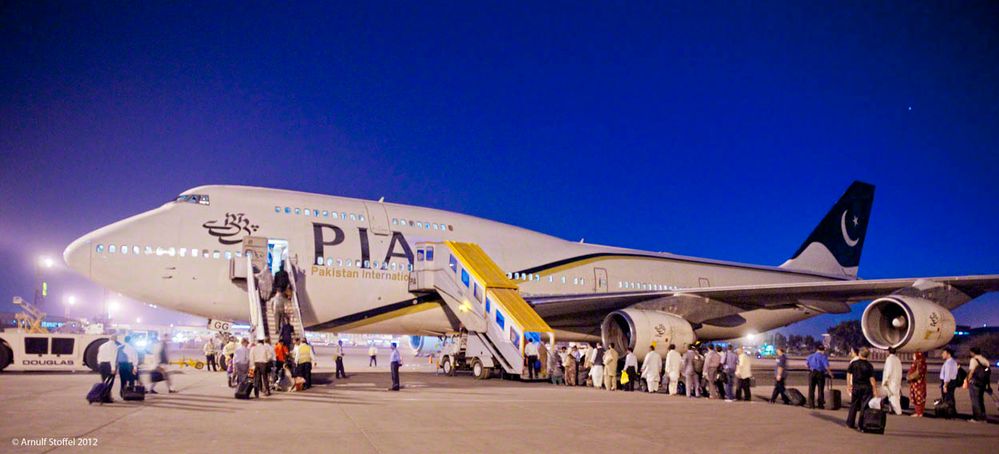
left=0, top=351, right=999, bottom=454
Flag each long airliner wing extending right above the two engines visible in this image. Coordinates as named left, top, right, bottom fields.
left=525, top=275, right=999, bottom=327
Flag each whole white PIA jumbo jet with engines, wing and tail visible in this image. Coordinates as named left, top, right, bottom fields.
left=64, top=181, right=999, bottom=368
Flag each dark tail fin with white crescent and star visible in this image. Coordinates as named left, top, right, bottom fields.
left=781, top=181, right=874, bottom=278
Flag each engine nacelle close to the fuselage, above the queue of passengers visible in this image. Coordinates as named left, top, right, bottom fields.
left=600, top=309, right=697, bottom=359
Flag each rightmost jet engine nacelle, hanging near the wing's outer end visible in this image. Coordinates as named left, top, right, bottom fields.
left=860, top=295, right=957, bottom=352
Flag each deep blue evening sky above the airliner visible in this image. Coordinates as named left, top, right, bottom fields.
left=0, top=1, right=999, bottom=333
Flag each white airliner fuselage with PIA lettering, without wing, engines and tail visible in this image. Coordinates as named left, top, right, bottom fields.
left=64, top=186, right=836, bottom=340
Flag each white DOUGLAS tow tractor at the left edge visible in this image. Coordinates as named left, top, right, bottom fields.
left=0, top=330, right=110, bottom=372
